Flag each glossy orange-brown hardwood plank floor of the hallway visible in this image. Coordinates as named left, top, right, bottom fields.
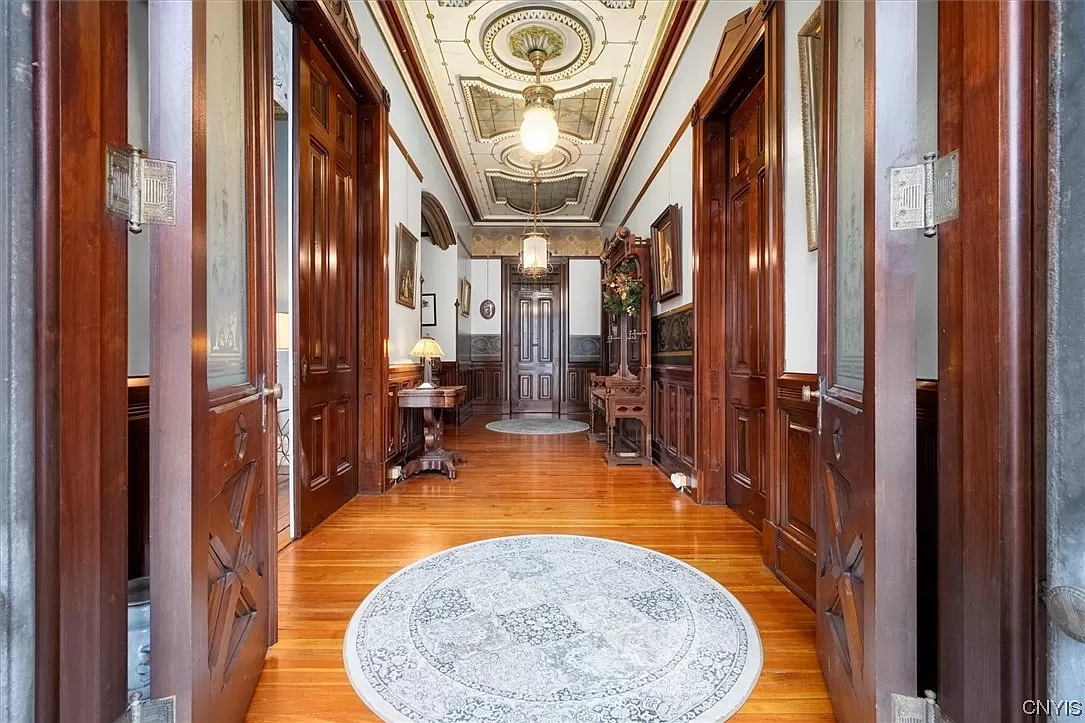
left=245, top=417, right=834, bottom=723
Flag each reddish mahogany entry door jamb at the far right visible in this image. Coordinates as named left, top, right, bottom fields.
left=936, top=1, right=1050, bottom=723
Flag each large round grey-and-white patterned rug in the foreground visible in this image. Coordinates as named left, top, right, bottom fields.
left=343, top=535, right=762, bottom=723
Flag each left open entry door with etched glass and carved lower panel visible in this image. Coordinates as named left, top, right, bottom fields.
left=149, top=2, right=276, bottom=723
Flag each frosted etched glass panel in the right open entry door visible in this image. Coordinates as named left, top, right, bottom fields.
left=834, top=2, right=865, bottom=392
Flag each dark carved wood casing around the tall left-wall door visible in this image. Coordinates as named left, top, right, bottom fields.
left=279, top=0, right=395, bottom=495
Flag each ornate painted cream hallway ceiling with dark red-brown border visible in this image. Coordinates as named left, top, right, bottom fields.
left=372, top=0, right=700, bottom=226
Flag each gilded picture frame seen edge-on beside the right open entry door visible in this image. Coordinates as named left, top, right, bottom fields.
left=799, top=7, right=822, bottom=251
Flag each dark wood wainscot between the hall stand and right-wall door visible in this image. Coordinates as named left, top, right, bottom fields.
left=652, top=364, right=693, bottom=477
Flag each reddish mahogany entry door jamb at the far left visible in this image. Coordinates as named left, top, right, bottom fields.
left=31, top=3, right=128, bottom=723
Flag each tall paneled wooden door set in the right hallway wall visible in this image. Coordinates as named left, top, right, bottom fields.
left=724, top=79, right=771, bottom=530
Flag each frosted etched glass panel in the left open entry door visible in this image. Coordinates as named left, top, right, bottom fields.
left=206, top=0, right=250, bottom=390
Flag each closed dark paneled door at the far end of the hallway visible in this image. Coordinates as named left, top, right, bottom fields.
left=509, top=275, right=561, bottom=414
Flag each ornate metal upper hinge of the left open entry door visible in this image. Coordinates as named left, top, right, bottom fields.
left=105, top=145, right=177, bottom=233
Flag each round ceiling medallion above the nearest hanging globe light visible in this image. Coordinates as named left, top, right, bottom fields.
left=481, top=5, right=595, bottom=83
